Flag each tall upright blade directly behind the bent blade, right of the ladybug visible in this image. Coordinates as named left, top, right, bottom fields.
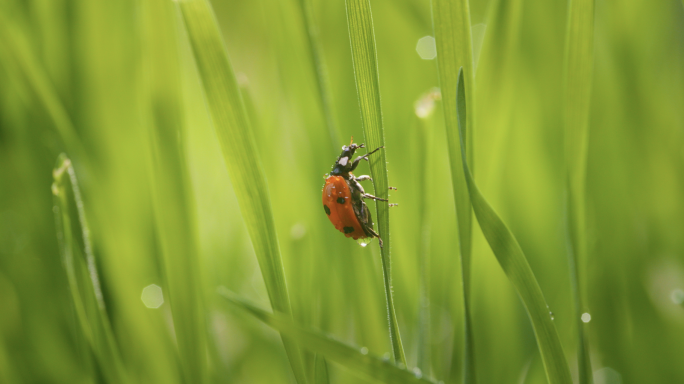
left=432, top=0, right=477, bottom=384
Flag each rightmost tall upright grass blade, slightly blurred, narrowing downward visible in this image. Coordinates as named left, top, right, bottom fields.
left=564, top=0, right=594, bottom=384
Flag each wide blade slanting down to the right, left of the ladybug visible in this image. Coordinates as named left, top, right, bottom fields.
left=179, top=0, right=306, bottom=384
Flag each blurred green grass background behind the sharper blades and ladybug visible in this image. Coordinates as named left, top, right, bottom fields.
left=0, top=0, right=684, bottom=383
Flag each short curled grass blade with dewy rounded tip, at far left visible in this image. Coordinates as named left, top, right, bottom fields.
left=52, top=154, right=128, bottom=383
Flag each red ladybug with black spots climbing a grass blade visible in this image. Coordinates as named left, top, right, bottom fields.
left=323, top=137, right=395, bottom=247
